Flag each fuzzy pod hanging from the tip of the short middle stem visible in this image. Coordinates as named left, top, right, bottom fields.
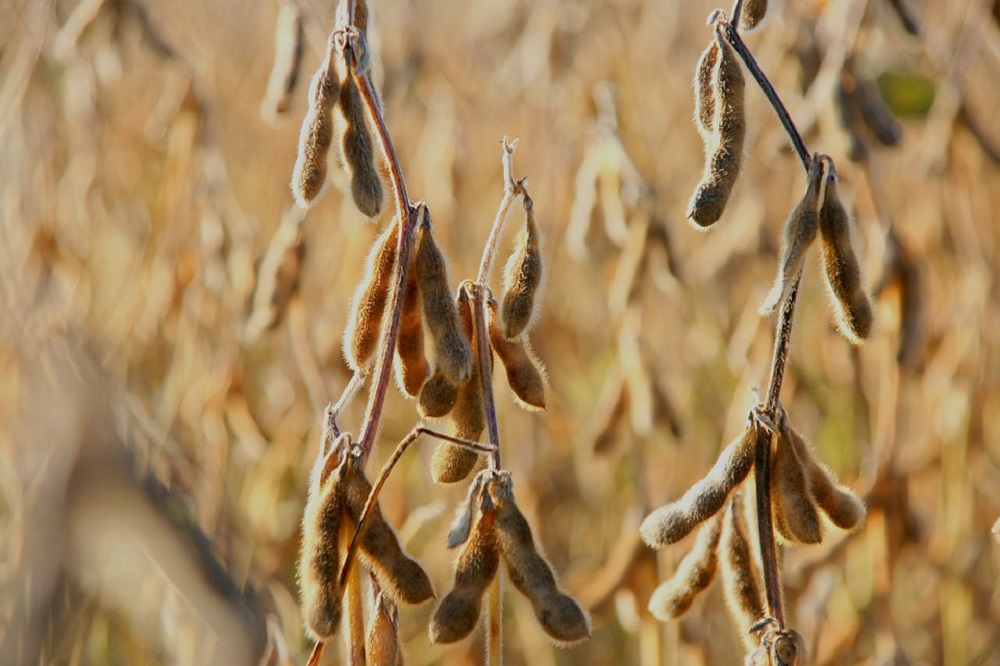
left=500, top=194, right=545, bottom=340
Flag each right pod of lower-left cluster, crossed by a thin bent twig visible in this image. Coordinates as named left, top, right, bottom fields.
left=344, top=452, right=434, bottom=604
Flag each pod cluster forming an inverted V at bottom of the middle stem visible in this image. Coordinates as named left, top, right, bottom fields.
left=429, top=470, right=590, bottom=645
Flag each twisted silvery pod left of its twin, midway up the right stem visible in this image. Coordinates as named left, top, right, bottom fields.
left=758, top=155, right=823, bottom=315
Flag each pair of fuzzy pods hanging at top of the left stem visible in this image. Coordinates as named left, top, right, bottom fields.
left=291, top=1, right=385, bottom=218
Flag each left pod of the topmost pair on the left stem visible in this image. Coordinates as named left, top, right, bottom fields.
left=292, top=37, right=340, bottom=208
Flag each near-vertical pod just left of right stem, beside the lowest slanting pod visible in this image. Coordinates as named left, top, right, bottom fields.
left=719, top=494, right=765, bottom=643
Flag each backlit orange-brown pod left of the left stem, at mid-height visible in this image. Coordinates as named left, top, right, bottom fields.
left=344, top=219, right=399, bottom=371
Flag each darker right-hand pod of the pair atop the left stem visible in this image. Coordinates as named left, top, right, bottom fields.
left=334, top=50, right=383, bottom=218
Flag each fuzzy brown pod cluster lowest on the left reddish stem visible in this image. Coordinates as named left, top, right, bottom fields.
left=299, top=419, right=434, bottom=649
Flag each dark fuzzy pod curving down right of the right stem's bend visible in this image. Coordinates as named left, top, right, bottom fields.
left=819, top=162, right=875, bottom=345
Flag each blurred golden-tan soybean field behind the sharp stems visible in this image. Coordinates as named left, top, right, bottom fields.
left=0, top=0, right=1000, bottom=666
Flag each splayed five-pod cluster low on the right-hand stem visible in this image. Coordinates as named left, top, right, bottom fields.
left=640, top=404, right=865, bottom=627
